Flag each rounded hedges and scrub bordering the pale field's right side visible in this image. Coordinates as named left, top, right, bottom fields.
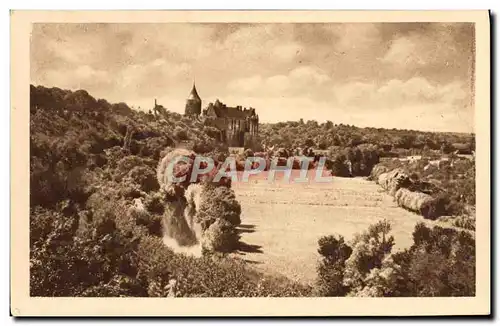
left=370, top=157, right=476, bottom=230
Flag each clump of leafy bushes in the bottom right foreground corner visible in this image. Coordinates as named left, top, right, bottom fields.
left=317, top=222, right=475, bottom=297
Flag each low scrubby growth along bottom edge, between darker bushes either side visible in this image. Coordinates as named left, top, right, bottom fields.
left=139, top=237, right=311, bottom=297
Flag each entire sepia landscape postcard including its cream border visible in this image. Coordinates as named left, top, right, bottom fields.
left=11, top=11, right=490, bottom=316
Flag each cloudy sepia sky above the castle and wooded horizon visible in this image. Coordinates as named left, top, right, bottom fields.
left=30, top=23, right=474, bottom=132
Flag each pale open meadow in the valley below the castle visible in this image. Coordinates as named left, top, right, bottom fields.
left=233, top=172, right=434, bottom=283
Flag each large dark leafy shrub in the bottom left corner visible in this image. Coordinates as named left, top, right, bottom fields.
left=30, top=202, right=143, bottom=296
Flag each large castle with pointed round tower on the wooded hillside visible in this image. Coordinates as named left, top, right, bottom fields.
left=184, top=83, right=259, bottom=148
